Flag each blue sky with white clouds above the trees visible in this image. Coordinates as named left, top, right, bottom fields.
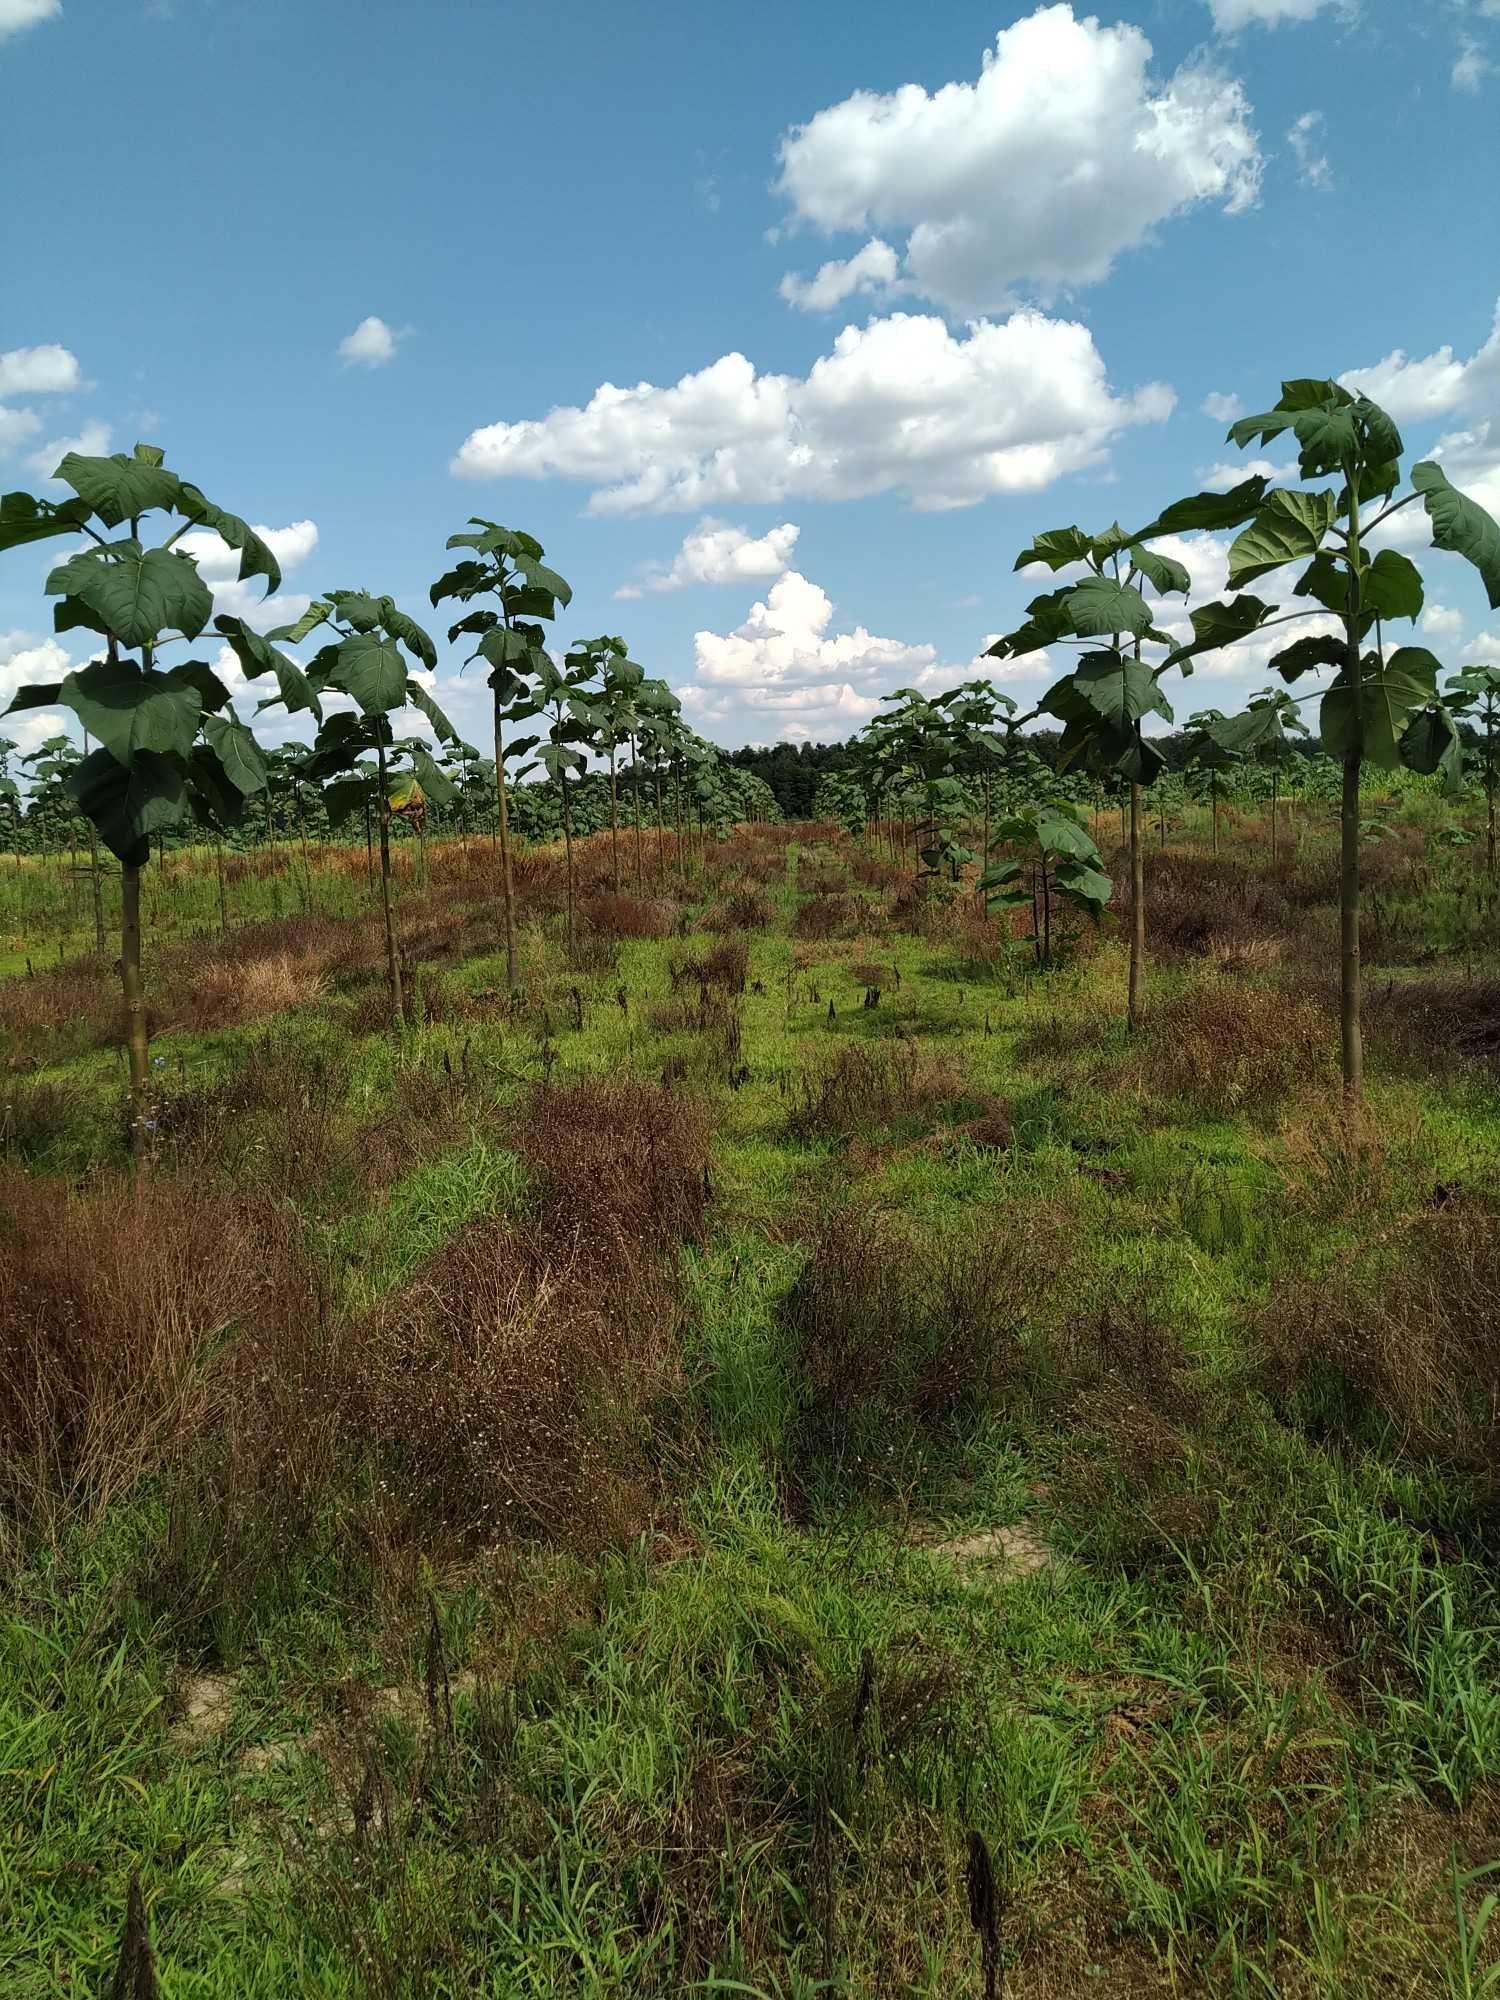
left=0, top=0, right=1500, bottom=764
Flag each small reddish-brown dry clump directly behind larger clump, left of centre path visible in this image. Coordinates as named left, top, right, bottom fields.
left=520, top=1078, right=710, bottom=1252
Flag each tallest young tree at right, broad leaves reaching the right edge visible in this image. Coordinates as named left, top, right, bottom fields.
left=1220, top=378, right=1500, bottom=1104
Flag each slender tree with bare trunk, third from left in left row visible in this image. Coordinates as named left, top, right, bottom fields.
left=438, top=514, right=572, bottom=986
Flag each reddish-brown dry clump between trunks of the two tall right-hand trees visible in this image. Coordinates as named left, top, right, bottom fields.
left=1108, top=974, right=1336, bottom=1116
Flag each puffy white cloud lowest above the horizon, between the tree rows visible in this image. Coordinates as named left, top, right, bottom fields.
left=692, top=570, right=936, bottom=698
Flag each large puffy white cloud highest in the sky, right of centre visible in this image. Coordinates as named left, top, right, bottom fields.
left=776, top=6, right=1260, bottom=314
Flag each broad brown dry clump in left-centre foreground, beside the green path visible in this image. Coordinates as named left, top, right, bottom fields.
left=336, top=1216, right=680, bottom=1546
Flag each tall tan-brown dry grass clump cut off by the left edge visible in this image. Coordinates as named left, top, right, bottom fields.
left=0, top=1168, right=316, bottom=1520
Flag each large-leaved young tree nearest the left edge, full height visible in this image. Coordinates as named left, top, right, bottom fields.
left=0, top=444, right=302, bottom=1158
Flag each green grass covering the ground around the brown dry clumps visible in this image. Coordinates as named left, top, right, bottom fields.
left=0, top=820, right=1500, bottom=2000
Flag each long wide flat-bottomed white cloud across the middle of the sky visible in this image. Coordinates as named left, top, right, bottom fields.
left=452, top=312, right=1174, bottom=514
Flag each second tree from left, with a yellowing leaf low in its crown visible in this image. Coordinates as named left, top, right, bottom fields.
left=292, top=590, right=458, bottom=1028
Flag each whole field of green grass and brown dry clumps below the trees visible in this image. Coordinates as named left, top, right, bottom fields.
left=0, top=796, right=1500, bottom=2000
